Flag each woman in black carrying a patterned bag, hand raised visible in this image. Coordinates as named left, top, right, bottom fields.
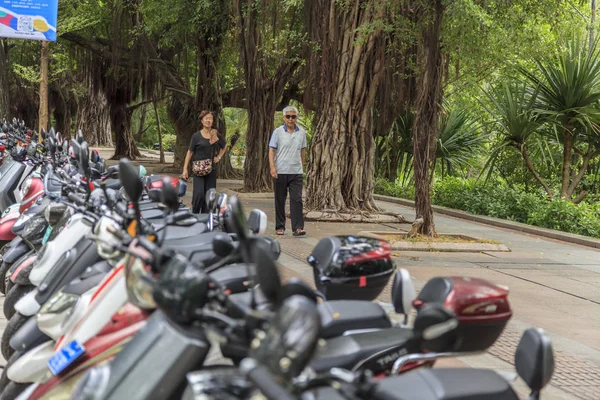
left=182, top=110, right=227, bottom=214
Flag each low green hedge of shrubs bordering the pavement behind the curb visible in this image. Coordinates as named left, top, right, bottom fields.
left=375, top=177, right=600, bottom=238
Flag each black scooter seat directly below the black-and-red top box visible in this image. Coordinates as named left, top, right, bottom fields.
left=317, top=300, right=392, bottom=339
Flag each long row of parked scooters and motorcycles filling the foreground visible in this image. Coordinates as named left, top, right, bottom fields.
left=0, top=121, right=554, bottom=400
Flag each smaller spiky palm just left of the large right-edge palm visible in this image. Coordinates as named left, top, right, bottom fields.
left=482, top=81, right=554, bottom=200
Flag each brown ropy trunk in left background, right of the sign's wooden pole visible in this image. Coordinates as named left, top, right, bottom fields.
left=75, top=90, right=112, bottom=147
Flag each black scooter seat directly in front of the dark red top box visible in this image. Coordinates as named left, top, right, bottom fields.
left=310, top=328, right=414, bottom=373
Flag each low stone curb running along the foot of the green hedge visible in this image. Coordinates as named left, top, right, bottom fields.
left=373, top=194, right=600, bottom=249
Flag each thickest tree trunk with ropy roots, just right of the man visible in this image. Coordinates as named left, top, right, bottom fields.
left=306, top=0, right=385, bottom=212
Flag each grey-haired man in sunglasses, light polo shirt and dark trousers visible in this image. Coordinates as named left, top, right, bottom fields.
left=269, top=106, right=306, bottom=236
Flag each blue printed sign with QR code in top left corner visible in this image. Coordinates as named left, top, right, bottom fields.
left=0, top=0, right=58, bottom=42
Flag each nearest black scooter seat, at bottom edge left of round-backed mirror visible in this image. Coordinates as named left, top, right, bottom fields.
left=371, top=368, right=519, bottom=400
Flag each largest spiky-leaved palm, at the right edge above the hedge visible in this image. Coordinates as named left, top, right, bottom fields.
left=521, top=37, right=600, bottom=200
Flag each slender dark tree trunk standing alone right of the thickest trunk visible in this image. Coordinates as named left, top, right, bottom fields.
left=413, top=0, right=444, bottom=236
